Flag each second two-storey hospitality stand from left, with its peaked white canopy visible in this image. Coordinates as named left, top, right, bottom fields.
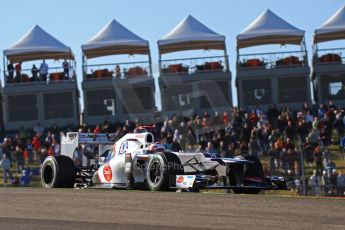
left=82, top=20, right=155, bottom=124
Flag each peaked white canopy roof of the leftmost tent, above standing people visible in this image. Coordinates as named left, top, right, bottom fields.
left=4, top=25, right=74, bottom=62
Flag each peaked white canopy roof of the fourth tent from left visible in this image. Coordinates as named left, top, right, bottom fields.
left=237, top=9, right=304, bottom=48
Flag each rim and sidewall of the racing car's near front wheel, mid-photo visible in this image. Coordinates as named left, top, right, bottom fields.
left=146, top=153, right=169, bottom=191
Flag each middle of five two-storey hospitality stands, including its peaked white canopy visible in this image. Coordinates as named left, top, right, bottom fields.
left=158, top=15, right=232, bottom=116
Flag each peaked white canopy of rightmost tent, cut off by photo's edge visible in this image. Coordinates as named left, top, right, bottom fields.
left=314, top=5, right=345, bottom=43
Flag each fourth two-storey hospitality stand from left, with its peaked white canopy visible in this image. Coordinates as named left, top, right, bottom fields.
left=236, top=10, right=311, bottom=109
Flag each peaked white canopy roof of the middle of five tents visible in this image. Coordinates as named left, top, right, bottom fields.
left=158, top=15, right=225, bottom=54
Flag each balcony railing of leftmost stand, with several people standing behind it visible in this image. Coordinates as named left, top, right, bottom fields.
left=4, top=67, right=76, bottom=86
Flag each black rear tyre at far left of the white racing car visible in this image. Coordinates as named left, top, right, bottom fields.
left=41, top=155, right=76, bottom=188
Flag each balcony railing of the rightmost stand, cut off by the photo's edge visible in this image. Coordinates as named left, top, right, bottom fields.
left=314, top=48, right=345, bottom=65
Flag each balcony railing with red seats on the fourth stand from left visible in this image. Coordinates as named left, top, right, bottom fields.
left=237, top=51, right=308, bottom=69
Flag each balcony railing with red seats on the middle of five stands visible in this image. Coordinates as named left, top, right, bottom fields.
left=160, top=56, right=227, bottom=75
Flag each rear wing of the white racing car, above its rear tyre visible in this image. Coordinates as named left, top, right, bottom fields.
left=61, top=132, right=119, bottom=159
